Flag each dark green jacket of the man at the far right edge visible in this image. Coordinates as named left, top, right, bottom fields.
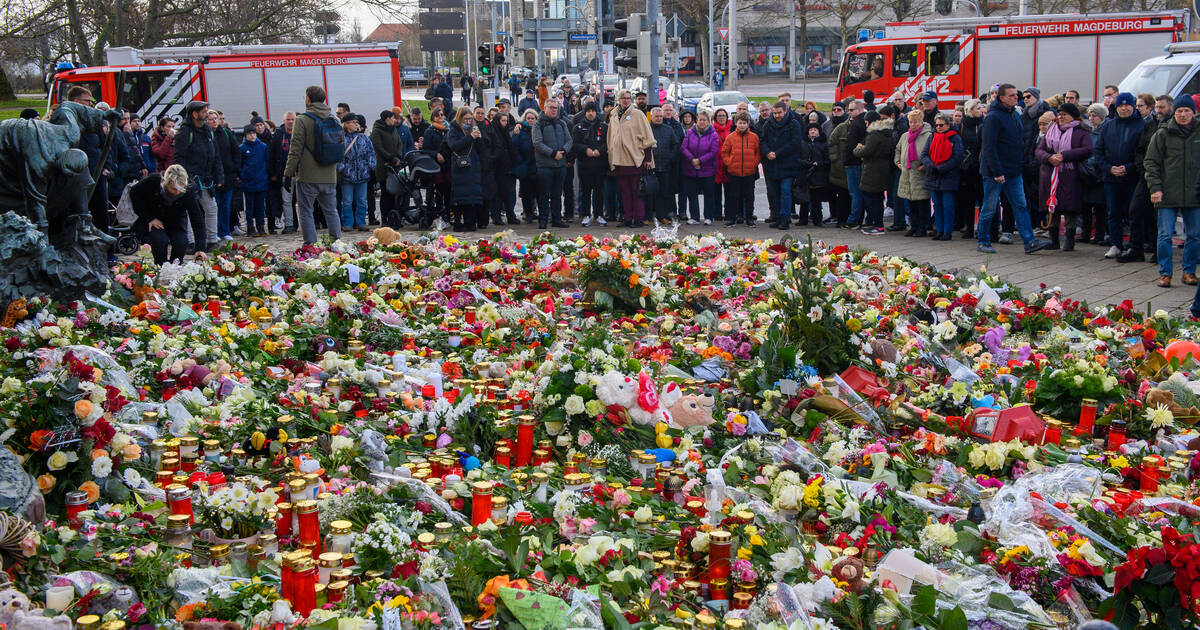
left=1142, top=119, right=1200, bottom=208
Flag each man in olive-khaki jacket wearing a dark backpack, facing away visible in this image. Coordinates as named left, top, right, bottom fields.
left=283, top=85, right=346, bottom=245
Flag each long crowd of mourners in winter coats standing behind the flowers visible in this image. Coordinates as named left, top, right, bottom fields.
left=58, top=72, right=1200, bottom=287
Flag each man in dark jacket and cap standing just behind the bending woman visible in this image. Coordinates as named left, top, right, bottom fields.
left=174, top=101, right=224, bottom=252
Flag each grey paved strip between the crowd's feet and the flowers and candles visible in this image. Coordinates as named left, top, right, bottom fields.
left=229, top=214, right=1195, bottom=314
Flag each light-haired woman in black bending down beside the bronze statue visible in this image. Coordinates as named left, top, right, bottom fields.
left=130, top=164, right=199, bottom=265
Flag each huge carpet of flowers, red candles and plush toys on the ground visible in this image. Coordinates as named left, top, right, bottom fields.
left=0, top=233, right=1200, bottom=630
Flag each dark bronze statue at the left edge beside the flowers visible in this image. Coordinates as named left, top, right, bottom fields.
left=0, top=102, right=120, bottom=305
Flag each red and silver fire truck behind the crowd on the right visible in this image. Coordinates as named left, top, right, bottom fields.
left=835, top=11, right=1188, bottom=107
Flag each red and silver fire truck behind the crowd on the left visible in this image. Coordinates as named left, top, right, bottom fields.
left=50, top=43, right=402, bottom=127
